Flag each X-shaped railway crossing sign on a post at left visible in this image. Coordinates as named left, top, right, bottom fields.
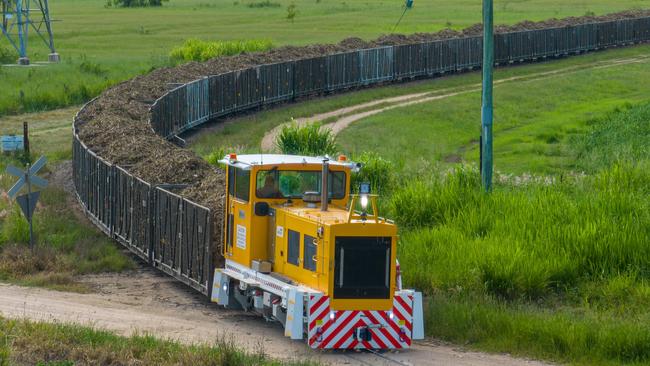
left=7, top=156, right=47, bottom=250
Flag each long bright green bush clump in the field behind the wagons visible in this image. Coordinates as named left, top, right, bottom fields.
left=169, top=39, right=274, bottom=62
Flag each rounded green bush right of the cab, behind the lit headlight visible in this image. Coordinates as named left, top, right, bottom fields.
left=351, top=152, right=396, bottom=195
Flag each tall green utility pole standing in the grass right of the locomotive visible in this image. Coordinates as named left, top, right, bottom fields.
left=481, top=0, right=494, bottom=192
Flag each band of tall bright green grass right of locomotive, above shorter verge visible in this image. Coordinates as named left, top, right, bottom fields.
left=389, top=164, right=650, bottom=300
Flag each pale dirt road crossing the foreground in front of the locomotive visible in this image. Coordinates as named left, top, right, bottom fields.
left=0, top=268, right=543, bottom=366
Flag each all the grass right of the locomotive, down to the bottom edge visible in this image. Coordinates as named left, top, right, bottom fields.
left=386, top=103, right=650, bottom=365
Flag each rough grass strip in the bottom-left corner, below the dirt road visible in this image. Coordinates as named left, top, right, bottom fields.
left=0, top=317, right=314, bottom=366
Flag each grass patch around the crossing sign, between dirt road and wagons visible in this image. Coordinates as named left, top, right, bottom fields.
left=0, top=155, right=133, bottom=291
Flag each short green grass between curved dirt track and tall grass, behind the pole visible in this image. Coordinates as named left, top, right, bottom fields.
left=339, top=47, right=650, bottom=174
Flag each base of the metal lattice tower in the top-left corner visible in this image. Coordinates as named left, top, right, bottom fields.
left=0, top=0, right=60, bottom=65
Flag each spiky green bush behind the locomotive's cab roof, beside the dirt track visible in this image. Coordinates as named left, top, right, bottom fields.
left=275, top=123, right=338, bottom=156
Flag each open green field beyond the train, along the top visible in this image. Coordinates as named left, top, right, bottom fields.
left=0, top=0, right=648, bottom=115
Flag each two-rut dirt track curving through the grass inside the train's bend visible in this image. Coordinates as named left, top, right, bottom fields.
left=261, top=56, right=650, bottom=151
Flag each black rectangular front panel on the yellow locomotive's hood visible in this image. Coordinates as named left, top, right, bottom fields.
left=334, top=237, right=391, bottom=299
